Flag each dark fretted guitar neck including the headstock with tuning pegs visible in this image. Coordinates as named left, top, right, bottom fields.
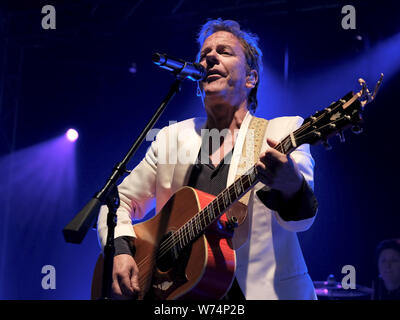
left=166, top=81, right=383, bottom=254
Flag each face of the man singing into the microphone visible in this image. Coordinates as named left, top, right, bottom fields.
left=199, top=31, right=253, bottom=105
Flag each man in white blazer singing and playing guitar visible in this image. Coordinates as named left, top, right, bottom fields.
left=98, top=19, right=317, bottom=300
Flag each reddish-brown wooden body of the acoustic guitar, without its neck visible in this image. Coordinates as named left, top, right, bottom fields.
left=92, top=187, right=236, bottom=300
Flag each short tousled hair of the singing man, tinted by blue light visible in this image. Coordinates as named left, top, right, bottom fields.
left=197, top=18, right=262, bottom=113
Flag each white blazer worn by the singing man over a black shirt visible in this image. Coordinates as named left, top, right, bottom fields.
left=98, top=113, right=316, bottom=299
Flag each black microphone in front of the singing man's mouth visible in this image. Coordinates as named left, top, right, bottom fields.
left=152, top=53, right=207, bottom=81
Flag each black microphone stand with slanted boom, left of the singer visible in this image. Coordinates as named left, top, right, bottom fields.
left=63, top=76, right=186, bottom=299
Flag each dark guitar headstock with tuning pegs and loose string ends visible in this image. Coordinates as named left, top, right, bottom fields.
left=291, top=74, right=383, bottom=149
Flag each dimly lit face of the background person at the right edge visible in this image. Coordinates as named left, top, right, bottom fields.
left=378, top=249, right=400, bottom=283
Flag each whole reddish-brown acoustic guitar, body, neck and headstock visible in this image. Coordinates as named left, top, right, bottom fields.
left=92, top=74, right=383, bottom=300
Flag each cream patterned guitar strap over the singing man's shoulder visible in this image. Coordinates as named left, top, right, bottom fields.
left=226, top=117, right=268, bottom=249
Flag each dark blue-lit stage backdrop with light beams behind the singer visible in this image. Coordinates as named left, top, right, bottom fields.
left=0, top=0, right=400, bottom=299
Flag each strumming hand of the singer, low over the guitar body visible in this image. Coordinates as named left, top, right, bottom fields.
left=112, top=254, right=140, bottom=300
